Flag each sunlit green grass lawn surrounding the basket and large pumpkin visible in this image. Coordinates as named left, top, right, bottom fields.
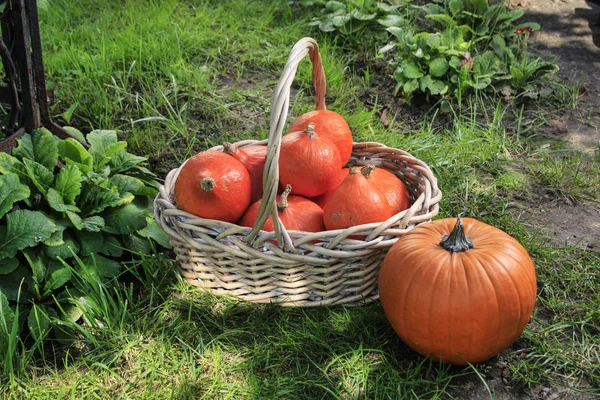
left=0, top=0, right=600, bottom=399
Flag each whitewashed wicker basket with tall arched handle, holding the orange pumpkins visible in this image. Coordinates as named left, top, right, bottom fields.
left=154, top=38, right=442, bottom=306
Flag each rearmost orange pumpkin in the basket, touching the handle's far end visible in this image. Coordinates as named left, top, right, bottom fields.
left=289, top=110, right=352, bottom=168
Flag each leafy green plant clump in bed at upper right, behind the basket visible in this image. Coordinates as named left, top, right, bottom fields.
left=380, top=0, right=558, bottom=98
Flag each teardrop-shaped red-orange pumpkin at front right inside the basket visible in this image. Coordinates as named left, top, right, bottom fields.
left=323, top=166, right=392, bottom=230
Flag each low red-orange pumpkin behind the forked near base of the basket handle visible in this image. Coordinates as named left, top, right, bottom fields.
left=239, top=185, right=324, bottom=232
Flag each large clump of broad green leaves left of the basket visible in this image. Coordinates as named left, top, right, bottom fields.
left=0, top=128, right=169, bottom=358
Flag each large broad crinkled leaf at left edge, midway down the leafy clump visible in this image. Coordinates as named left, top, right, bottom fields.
left=0, top=210, right=60, bottom=260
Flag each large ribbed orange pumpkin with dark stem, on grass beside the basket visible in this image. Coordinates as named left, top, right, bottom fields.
left=378, top=218, right=537, bottom=365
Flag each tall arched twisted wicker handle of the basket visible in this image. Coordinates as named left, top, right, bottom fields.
left=244, top=37, right=326, bottom=250
